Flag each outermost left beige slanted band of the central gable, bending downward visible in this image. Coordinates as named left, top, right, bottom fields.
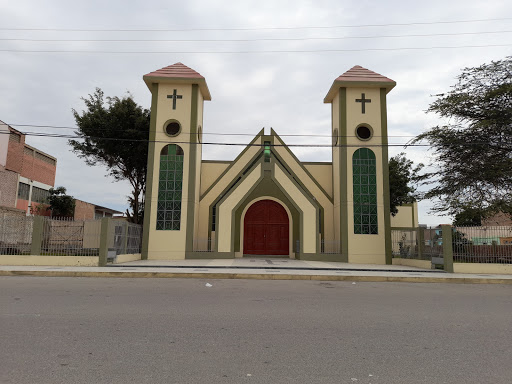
left=198, top=137, right=262, bottom=243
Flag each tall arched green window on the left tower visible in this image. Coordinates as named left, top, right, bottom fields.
left=156, top=144, right=183, bottom=231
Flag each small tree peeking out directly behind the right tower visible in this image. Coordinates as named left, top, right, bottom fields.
left=389, top=153, right=423, bottom=216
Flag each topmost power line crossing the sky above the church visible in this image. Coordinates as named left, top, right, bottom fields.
left=0, top=17, right=512, bottom=32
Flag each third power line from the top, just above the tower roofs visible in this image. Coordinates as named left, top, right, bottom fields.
left=0, top=44, right=512, bottom=55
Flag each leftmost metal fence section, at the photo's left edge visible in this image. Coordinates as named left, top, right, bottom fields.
left=0, top=214, right=34, bottom=255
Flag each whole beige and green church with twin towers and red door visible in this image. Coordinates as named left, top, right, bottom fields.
left=142, top=63, right=417, bottom=264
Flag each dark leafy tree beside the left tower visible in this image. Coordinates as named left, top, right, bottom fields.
left=69, top=88, right=150, bottom=223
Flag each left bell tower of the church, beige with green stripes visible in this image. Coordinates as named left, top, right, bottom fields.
left=142, top=63, right=211, bottom=259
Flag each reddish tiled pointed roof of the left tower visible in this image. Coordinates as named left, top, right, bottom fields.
left=143, top=63, right=212, bottom=100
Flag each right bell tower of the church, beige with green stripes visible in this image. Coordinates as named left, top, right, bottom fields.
left=324, top=66, right=396, bottom=264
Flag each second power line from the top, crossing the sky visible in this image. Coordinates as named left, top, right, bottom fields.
left=0, top=31, right=512, bottom=43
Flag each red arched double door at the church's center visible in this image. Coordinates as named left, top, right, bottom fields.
left=244, top=200, right=290, bottom=256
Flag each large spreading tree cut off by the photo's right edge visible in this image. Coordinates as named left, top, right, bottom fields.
left=412, top=57, right=512, bottom=216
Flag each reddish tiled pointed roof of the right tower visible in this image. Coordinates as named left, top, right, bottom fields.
left=324, top=65, right=396, bottom=103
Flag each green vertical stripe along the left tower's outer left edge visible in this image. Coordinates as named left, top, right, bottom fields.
left=141, top=83, right=158, bottom=260
